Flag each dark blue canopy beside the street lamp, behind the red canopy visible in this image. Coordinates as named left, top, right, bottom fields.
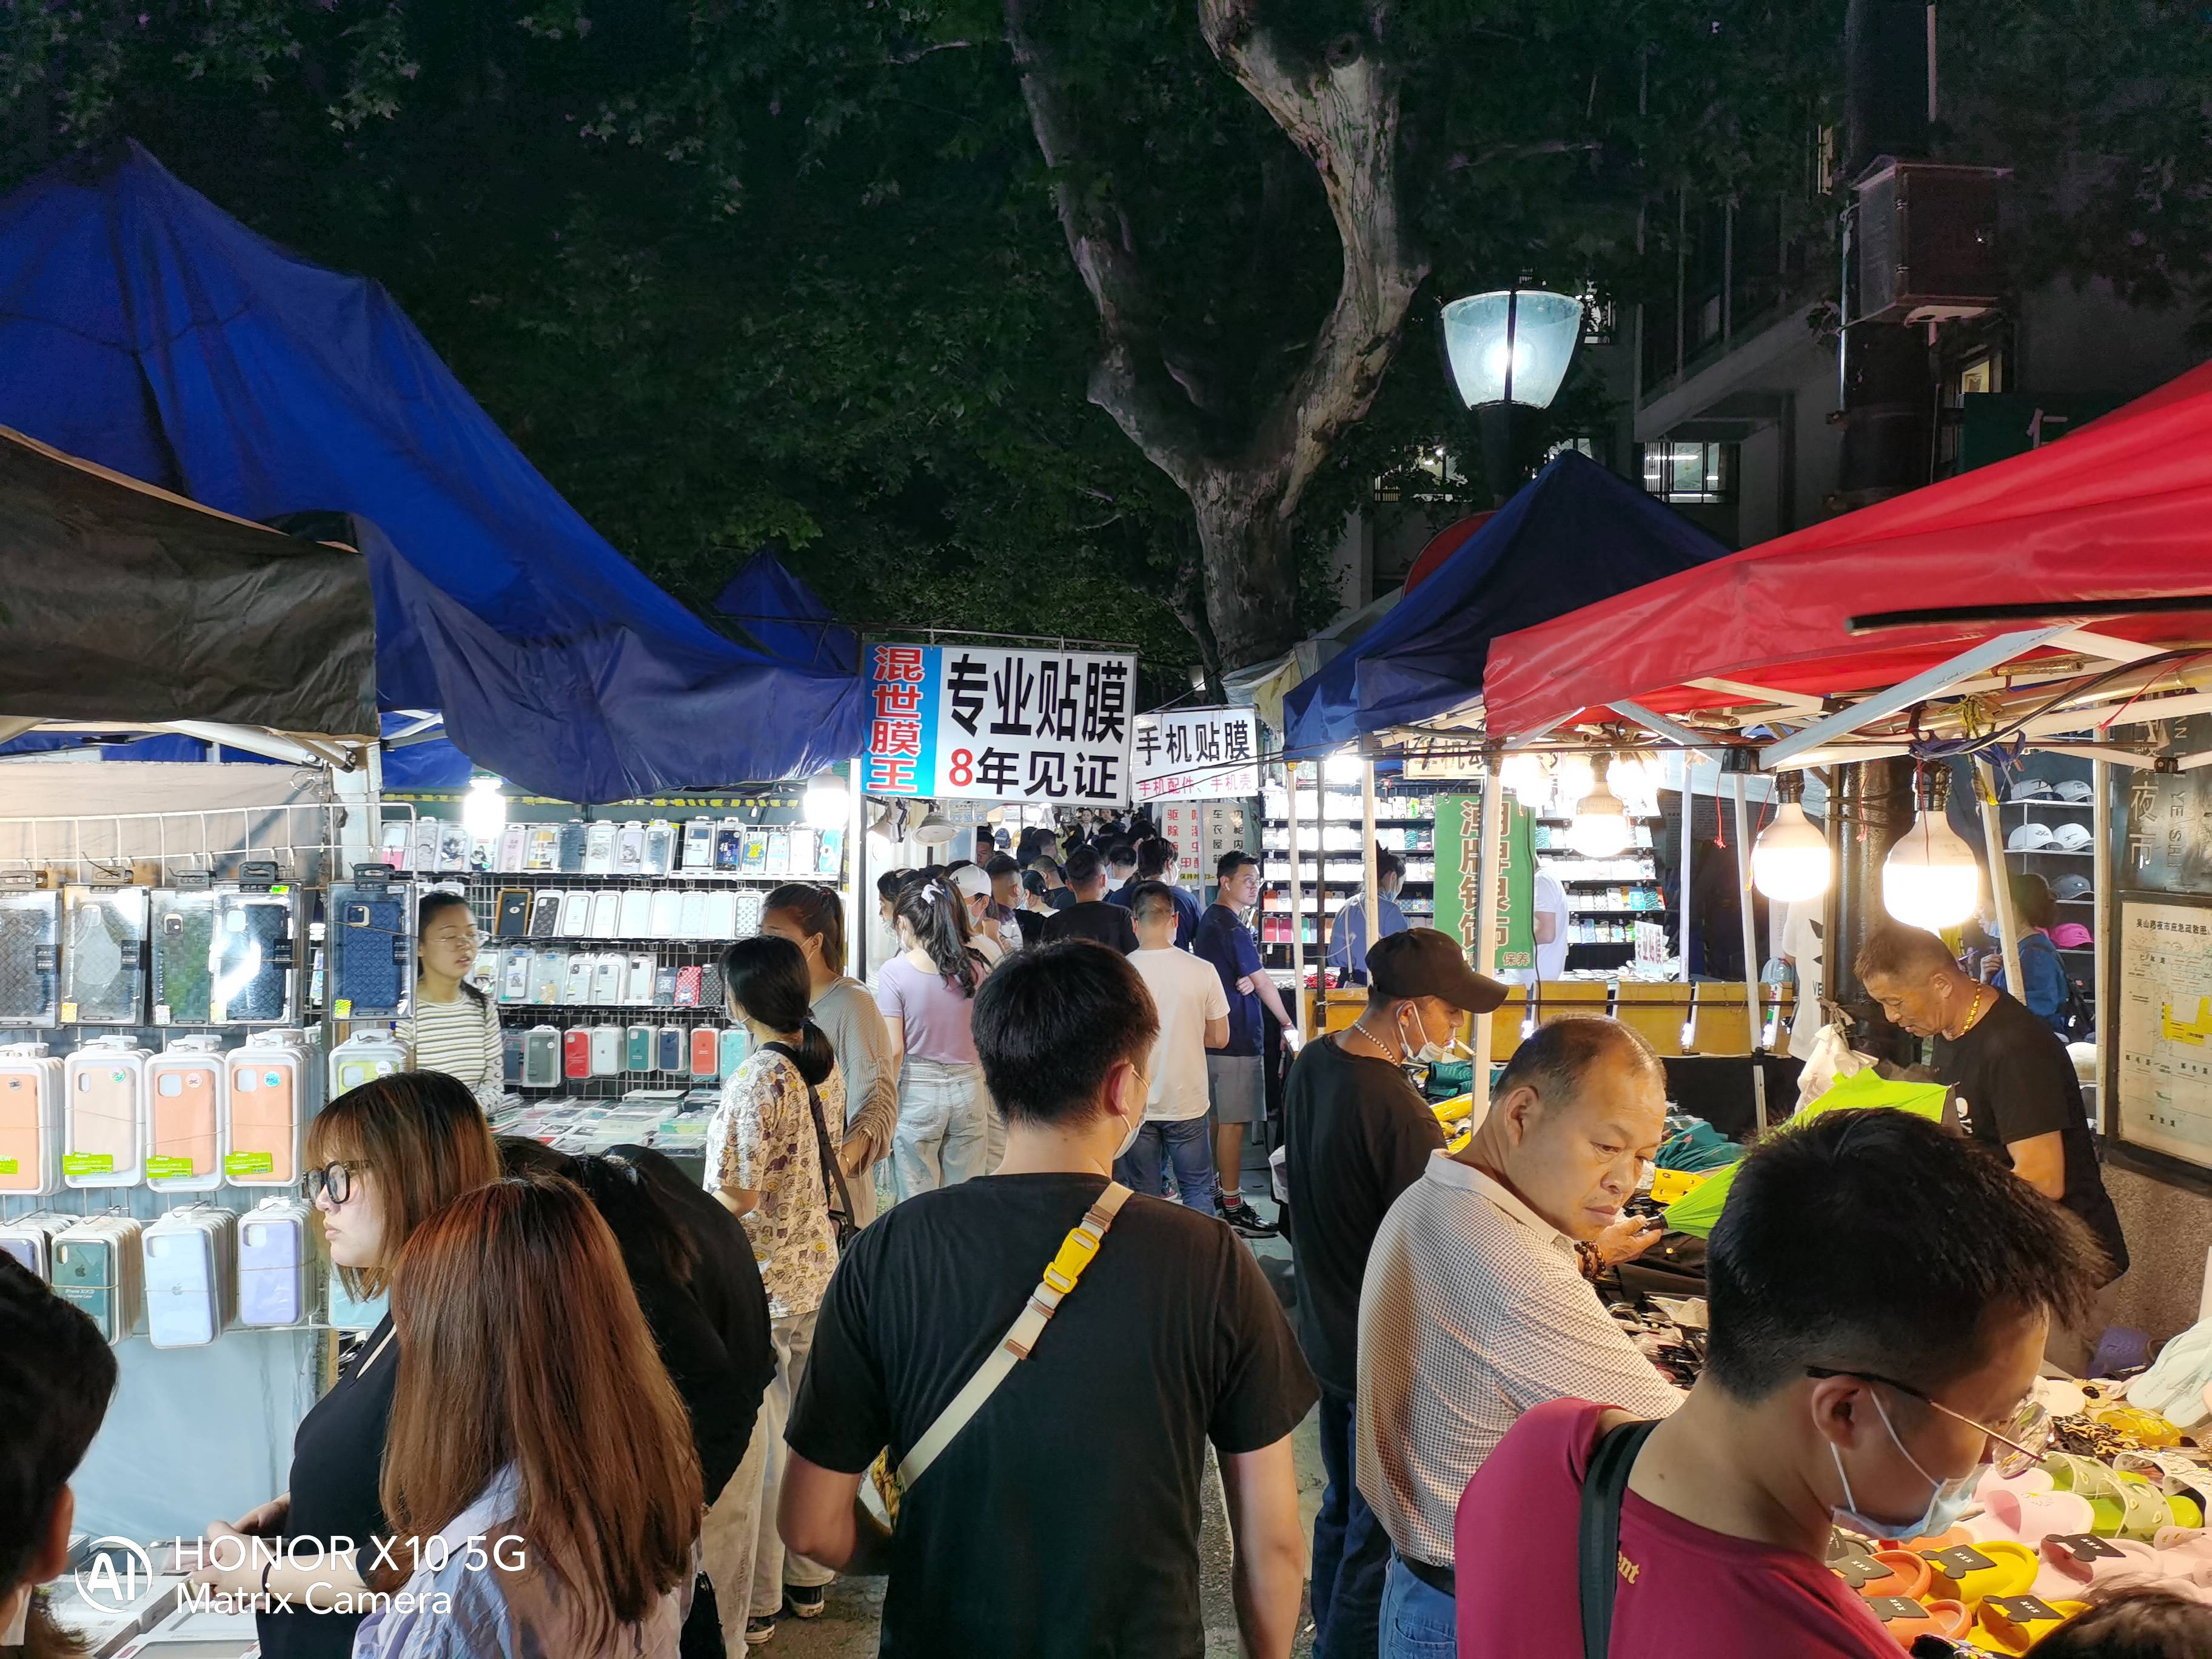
left=1283, top=449, right=1728, bottom=754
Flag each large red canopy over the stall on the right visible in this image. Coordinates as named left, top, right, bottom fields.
left=1482, top=363, right=2212, bottom=761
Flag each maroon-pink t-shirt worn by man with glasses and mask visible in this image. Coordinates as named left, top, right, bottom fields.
left=1453, top=1400, right=1898, bottom=1659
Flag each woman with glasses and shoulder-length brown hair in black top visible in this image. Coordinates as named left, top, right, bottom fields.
left=192, top=1071, right=500, bottom=1659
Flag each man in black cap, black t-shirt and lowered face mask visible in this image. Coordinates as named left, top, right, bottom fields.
left=1283, top=927, right=1506, bottom=1659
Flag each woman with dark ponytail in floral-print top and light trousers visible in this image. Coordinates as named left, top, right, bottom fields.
left=706, top=933, right=850, bottom=1643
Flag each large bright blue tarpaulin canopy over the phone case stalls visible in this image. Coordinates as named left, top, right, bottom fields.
left=0, top=144, right=867, bottom=801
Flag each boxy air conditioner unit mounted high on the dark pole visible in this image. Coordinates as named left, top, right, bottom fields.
left=1851, top=161, right=2004, bottom=323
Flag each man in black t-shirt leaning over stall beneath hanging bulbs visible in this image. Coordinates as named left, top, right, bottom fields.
left=1858, top=927, right=2128, bottom=1376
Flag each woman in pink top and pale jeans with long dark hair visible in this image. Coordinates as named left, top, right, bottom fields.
left=876, top=880, right=993, bottom=1199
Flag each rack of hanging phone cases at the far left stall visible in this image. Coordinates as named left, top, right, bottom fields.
left=0, top=801, right=389, bottom=1347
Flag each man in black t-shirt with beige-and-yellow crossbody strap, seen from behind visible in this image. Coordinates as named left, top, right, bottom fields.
left=779, top=942, right=1314, bottom=1659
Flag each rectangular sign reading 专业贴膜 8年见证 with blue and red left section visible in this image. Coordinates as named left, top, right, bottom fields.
left=863, top=646, right=1137, bottom=808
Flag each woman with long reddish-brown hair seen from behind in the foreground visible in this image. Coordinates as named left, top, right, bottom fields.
left=354, top=1175, right=701, bottom=1659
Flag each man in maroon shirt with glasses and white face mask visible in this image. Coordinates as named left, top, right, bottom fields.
left=1453, top=1110, right=2102, bottom=1659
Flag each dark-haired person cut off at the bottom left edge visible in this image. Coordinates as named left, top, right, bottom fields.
left=0, top=1256, right=117, bottom=1659
